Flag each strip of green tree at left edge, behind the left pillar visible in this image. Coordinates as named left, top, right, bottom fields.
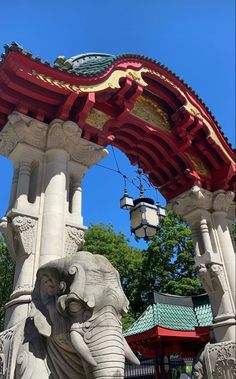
left=0, top=236, right=15, bottom=330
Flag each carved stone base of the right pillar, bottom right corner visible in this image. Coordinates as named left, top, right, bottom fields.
left=192, top=341, right=236, bottom=379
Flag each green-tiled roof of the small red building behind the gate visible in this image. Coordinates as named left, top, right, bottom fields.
left=124, top=294, right=213, bottom=337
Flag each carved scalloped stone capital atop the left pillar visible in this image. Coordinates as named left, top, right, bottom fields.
left=0, top=112, right=107, bottom=167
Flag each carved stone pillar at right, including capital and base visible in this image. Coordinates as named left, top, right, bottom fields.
left=169, top=186, right=236, bottom=379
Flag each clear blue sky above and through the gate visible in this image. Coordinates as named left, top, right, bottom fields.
left=0, top=0, right=235, bottom=246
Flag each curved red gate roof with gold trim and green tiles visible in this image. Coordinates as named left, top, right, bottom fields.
left=0, top=42, right=236, bottom=200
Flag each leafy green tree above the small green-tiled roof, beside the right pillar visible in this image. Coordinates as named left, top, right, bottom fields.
left=143, top=211, right=204, bottom=295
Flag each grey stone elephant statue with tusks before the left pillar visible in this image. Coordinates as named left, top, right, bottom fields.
left=10, top=251, right=139, bottom=379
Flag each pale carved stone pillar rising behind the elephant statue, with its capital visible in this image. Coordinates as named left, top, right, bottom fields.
left=0, top=112, right=106, bottom=328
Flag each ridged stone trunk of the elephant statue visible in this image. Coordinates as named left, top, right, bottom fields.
left=84, top=307, right=125, bottom=379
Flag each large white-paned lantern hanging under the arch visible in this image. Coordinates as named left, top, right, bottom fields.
left=130, top=197, right=164, bottom=239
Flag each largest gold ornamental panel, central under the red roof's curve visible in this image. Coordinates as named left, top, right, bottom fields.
left=130, top=95, right=171, bottom=132
